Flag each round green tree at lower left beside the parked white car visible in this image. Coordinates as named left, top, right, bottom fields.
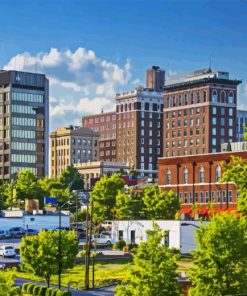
left=20, top=231, right=78, bottom=287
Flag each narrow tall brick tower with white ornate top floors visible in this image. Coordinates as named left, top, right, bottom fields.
left=116, top=87, right=164, bottom=178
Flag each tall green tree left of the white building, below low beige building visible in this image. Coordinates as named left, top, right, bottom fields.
left=90, top=174, right=124, bottom=222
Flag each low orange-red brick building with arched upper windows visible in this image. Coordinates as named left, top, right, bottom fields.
left=159, top=151, right=247, bottom=213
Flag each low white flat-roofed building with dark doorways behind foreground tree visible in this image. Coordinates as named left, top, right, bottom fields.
left=112, top=220, right=204, bottom=254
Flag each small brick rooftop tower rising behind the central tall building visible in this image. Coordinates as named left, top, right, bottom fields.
left=146, top=66, right=165, bottom=92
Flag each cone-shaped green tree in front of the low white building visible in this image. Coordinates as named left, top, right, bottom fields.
left=116, top=224, right=179, bottom=296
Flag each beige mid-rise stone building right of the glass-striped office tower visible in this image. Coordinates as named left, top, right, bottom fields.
left=50, top=126, right=99, bottom=178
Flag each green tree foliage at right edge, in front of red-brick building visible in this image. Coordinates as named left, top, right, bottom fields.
left=221, top=157, right=247, bottom=216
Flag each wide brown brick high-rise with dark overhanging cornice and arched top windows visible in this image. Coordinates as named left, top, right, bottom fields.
left=163, top=69, right=241, bottom=157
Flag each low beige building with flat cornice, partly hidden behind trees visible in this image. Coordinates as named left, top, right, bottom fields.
left=75, top=161, right=129, bottom=189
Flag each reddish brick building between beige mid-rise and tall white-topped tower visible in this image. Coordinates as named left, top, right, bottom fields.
left=82, top=112, right=116, bottom=162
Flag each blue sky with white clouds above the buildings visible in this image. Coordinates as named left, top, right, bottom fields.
left=0, top=0, right=247, bottom=129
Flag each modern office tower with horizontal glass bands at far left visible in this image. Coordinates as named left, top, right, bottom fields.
left=0, top=70, right=49, bottom=181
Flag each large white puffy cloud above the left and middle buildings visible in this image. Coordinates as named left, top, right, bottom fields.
left=4, top=47, right=131, bottom=130
